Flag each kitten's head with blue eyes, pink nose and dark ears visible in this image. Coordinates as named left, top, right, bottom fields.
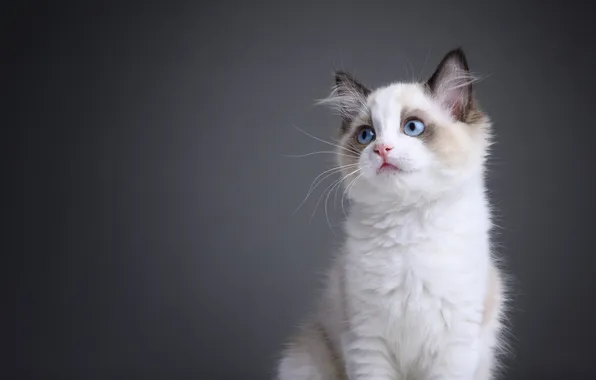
left=322, top=49, right=490, bottom=203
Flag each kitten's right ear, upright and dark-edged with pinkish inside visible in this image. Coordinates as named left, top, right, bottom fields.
left=426, top=48, right=475, bottom=121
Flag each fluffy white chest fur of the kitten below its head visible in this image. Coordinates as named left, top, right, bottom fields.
left=344, top=190, right=490, bottom=368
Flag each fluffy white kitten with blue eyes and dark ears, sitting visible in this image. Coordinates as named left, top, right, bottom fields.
left=277, top=49, right=505, bottom=380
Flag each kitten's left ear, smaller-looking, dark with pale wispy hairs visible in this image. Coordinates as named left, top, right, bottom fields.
left=328, top=71, right=371, bottom=122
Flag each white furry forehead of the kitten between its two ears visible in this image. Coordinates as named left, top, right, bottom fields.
left=368, top=83, right=434, bottom=115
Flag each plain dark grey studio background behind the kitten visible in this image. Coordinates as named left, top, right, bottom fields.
left=8, top=0, right=596, bottom=380
